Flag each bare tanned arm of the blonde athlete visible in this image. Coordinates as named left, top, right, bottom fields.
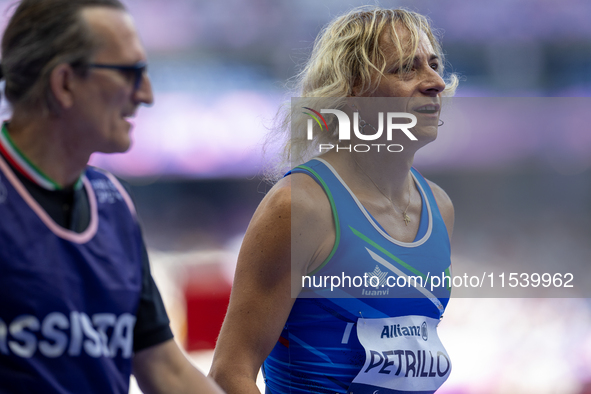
left=210, top=174, right=334, bottom=394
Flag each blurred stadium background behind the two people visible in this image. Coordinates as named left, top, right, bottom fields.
left=0, top=0, right=591, bottom=394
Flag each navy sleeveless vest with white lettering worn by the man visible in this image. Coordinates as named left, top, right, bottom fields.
left=0, top=157, right=142, bottom=393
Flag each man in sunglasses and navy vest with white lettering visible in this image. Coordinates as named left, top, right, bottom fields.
left=0, top=0, right=221, bottom=393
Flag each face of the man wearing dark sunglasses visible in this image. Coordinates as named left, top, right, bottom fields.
left=71, top=7, right=153, bottom=154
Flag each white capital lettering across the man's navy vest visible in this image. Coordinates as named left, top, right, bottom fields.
left=0, top=311, right=136, bottom=358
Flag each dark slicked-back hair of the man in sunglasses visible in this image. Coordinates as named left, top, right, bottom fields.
left=2, top=0, right=125, bottom=114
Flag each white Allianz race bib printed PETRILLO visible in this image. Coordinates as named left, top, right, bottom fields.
left=348, top=315, right=451, bottom=394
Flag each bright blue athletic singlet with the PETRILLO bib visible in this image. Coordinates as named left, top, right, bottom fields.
left=263, top=159, right=451, bottom=394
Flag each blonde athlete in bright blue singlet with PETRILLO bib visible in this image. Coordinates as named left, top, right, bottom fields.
left=211, top=8, right=457, bottom=394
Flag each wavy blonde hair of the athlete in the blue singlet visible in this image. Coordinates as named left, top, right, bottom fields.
left=267, top=7, right=459, bottom=180
